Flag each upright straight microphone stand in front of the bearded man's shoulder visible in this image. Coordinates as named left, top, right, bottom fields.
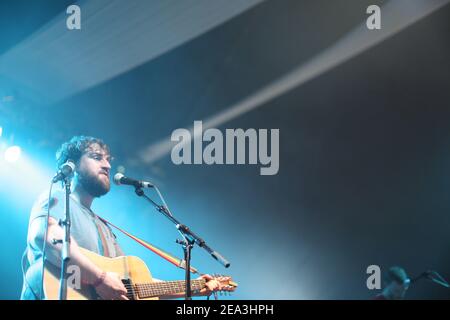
left=57, top=177, right=71, bottom=300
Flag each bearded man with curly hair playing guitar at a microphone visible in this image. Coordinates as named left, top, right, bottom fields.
left=21, top=136, right=221, bottom=300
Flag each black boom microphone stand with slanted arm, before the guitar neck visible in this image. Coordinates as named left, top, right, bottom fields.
left=135, top=186, right=230, bottom=300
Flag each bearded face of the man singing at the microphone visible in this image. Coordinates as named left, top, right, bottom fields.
left=77, top=143, right=111, bottom=197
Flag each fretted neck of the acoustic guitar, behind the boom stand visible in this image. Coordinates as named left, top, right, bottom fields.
left=133, top=279, right=206, bottom=299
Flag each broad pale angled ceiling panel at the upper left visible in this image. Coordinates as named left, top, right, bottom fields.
left=0, top=0, right=262, bottom=103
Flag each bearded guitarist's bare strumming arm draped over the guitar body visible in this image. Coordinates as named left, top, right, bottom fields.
left=29, top=217, right=128, bottom=300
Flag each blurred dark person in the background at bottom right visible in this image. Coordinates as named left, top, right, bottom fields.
left=375, top=267, right=411, bottom=300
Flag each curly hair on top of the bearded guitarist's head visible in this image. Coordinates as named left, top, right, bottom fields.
left=56, top=136, right=110, bottom=168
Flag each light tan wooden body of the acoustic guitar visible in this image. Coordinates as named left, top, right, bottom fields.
left=44, top=248, right=158, bottom=300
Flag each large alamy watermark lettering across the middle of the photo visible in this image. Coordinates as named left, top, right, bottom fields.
left=171, top=121, right=280, bottom=176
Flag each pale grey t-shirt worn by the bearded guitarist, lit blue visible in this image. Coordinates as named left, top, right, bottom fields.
left=21, top=190, right=123, bottom=300
